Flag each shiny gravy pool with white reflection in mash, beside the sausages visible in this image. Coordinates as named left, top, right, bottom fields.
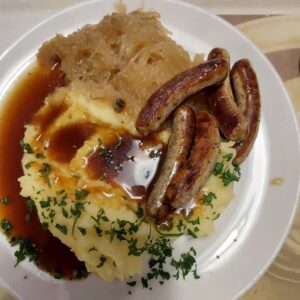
left=87, top=134, right=165, bottom=200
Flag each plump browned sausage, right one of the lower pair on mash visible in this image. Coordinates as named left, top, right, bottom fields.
left=166, top=111, right=220, bottom=208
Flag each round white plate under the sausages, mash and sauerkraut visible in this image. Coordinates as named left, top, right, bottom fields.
left=0, top=0, right=300, bottom=300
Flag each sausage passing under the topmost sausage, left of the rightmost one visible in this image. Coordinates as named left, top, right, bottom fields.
left=208, top=48, right=248, bottom=141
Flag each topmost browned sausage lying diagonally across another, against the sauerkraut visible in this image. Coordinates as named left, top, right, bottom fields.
left=136, top=59, right=228, bottom=135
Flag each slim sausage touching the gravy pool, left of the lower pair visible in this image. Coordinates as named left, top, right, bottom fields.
left=146, top=107, right=195, bottom=221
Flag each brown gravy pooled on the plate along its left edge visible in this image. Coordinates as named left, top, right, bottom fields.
left=0, top=67, right=86, bottom=279
